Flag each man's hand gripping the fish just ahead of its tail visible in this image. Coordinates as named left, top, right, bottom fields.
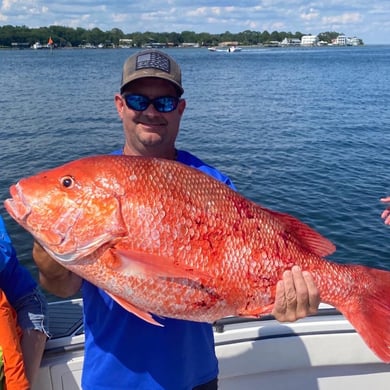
left=272, top=266, right=320, bottom=322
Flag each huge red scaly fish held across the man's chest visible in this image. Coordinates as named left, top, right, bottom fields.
left=5, top=156, right=390, bottom=362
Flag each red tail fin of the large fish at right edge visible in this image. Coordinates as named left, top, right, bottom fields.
left=340, top=266, right=390, bottom=363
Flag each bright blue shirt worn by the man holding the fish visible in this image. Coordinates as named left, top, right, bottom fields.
left=82, top=151, right=234, bottom=390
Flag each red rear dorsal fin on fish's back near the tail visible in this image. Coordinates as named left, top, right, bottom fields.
left=268, top=210, right=336, bottom=257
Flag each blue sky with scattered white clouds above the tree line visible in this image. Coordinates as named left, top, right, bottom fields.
left=0, top=0, right=390, bottom=44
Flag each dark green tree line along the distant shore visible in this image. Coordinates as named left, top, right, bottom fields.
left=0, top=25, right=348, bottom=48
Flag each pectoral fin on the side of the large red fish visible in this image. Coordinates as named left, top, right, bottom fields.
left=112, top=249, right=211, bottom=283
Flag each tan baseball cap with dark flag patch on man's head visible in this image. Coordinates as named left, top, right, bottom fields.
left=121, top=49, right=184, bottom=95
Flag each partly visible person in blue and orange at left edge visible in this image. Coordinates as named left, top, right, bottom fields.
left=0, top=217, right=48, bottom=390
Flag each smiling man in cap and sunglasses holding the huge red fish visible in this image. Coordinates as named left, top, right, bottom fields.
left=33, top=50, right=319, bottom=390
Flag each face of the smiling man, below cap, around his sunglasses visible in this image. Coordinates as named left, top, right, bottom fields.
left=115, top=77, right=185, bottom=159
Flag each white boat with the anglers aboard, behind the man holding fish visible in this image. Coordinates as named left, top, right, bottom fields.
left=32, top=299, right=390, bottom=390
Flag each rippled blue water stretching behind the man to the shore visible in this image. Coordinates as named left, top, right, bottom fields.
left=0, top=46, right=390, bottom=284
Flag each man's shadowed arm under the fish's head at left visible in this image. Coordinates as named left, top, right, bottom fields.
left=33, top=242, right=82, bottom=298
